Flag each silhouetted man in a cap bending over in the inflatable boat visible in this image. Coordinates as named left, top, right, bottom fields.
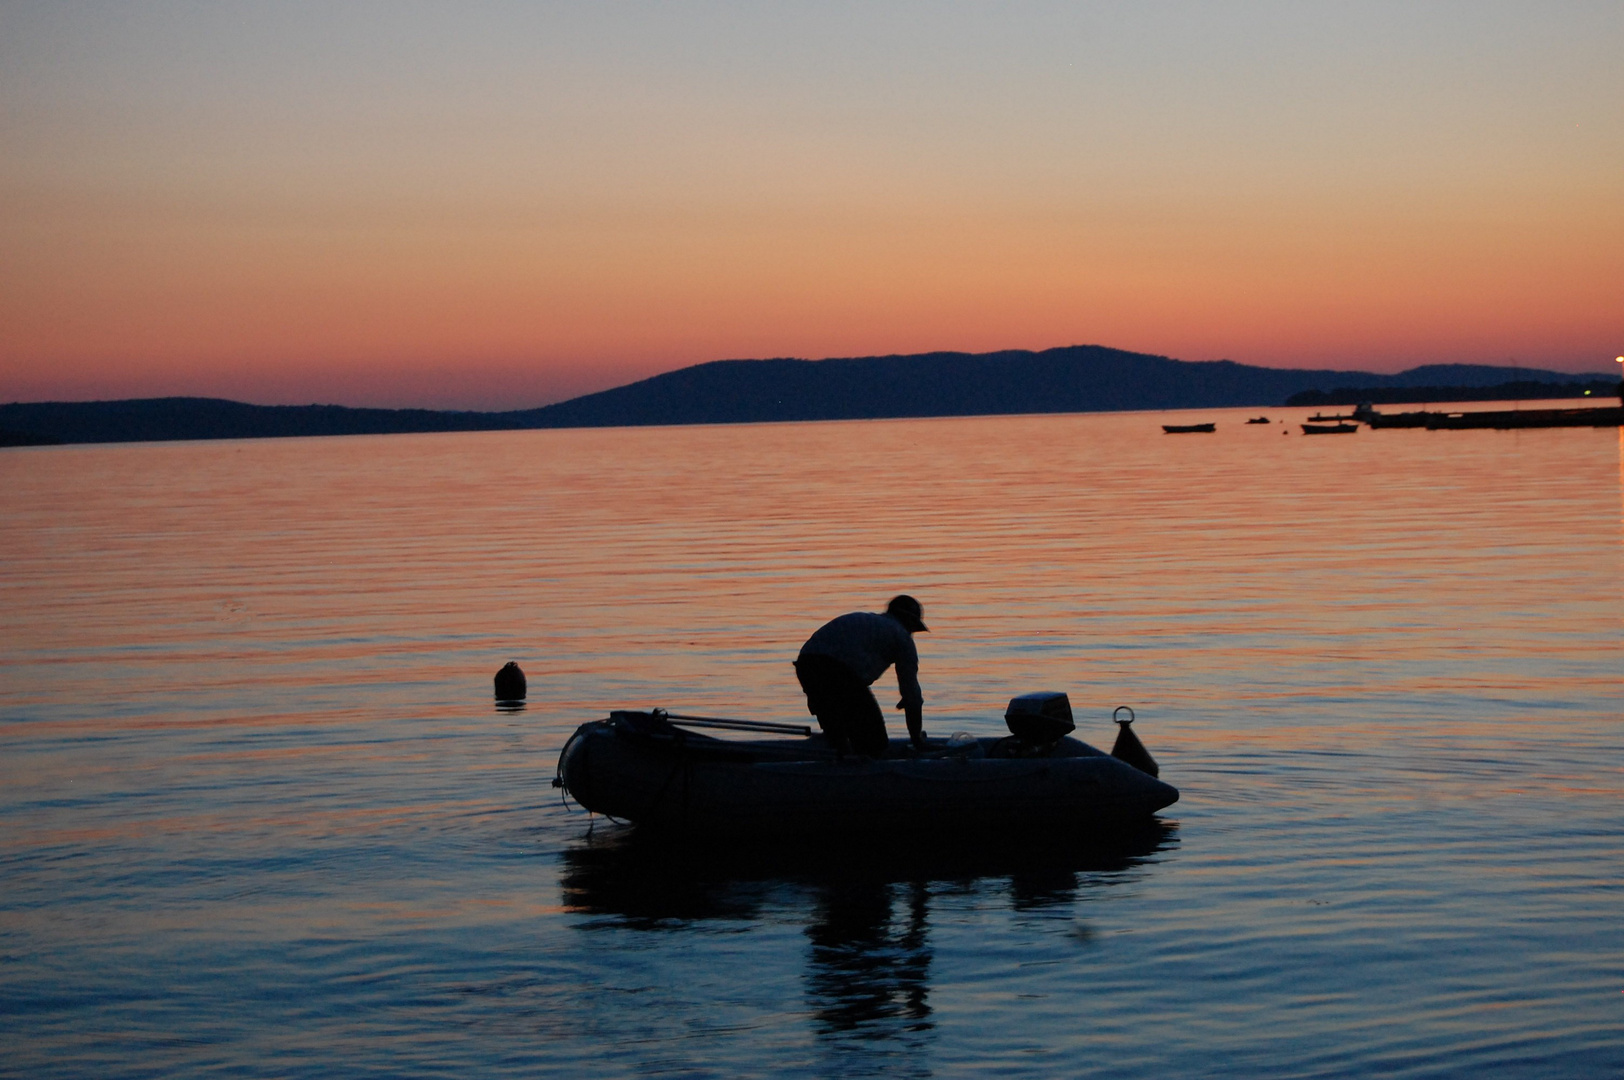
left=796, top=596, right=929, bottom=757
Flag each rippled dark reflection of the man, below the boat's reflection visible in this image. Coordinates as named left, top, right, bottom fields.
left=806, top=880, right=932, bottom=1035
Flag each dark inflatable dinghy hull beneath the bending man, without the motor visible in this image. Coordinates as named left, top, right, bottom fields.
left=559, top=719, right=1179, bottom=836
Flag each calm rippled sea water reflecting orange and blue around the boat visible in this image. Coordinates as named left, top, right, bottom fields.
left=0, top=411, right=1624, bottom=1077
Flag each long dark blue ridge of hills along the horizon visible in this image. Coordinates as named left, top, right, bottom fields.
left=0, top=346, right=1598, bottom=445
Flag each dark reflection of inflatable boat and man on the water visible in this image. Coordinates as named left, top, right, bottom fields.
left=560, top=820, right=1177, bottom=1038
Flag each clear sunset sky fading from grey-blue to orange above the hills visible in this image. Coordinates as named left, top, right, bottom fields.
left=0, top=0, right=1624, bottom=409
